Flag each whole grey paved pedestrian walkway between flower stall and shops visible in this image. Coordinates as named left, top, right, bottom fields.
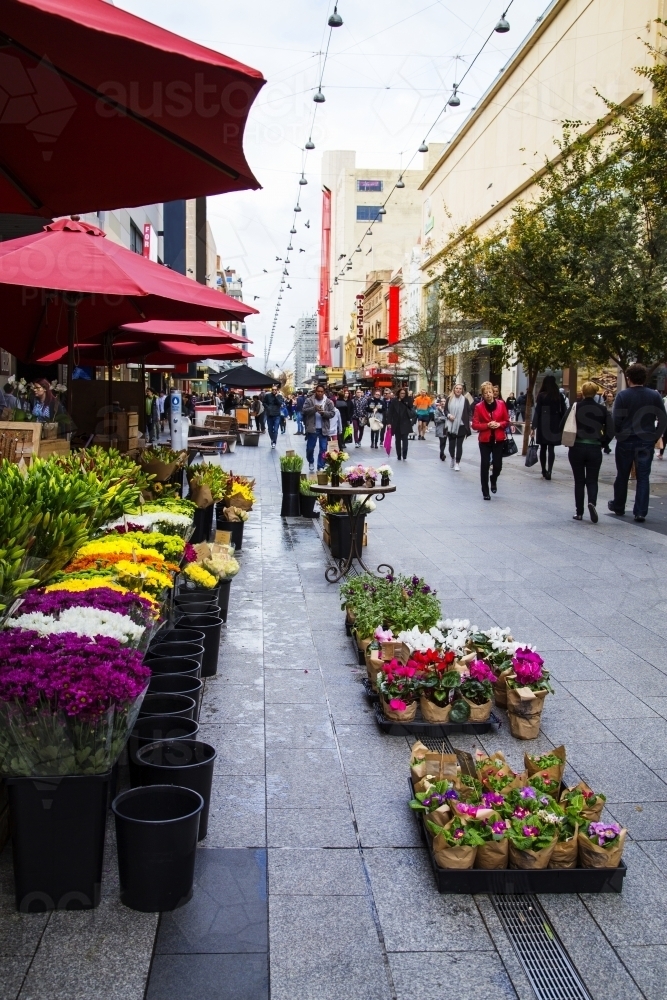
left=0, top=424, right=667, bottom=1000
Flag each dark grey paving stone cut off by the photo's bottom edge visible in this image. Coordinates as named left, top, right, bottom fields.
left=146, top=955, right=269, bottom=1000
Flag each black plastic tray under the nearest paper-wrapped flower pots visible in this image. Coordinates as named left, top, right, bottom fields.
left=408, top=778, right=627, bottom=896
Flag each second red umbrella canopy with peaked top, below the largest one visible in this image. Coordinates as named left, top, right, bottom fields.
left=0, top=219, right=256, bottom=362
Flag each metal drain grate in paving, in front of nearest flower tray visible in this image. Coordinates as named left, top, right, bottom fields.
left=490, top=895, right=591, bottom=1000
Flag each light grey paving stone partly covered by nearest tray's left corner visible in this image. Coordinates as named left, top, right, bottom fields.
left=364, top=848, right=493, bottom=952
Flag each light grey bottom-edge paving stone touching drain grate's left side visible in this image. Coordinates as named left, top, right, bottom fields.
left=389, top=947, right=517, bottom=1000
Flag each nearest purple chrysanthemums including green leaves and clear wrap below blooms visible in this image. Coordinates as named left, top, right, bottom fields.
left=0, top=629, right=150, bottom=777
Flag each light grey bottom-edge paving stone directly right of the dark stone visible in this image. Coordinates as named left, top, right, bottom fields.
left=269, top=896, right=390, bottom=1000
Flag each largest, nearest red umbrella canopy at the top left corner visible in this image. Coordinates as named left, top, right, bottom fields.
left=0, top=0, right=265, bottom=216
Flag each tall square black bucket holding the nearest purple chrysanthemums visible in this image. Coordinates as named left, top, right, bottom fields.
left=5, top=771, right=111, bottom=913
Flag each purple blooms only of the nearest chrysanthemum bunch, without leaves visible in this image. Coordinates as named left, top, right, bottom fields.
left=0, top=629, right=151, bottom=719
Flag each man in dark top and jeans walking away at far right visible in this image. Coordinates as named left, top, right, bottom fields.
left=607, top=364, right=667, bottom=522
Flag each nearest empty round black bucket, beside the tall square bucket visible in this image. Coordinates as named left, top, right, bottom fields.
left=111, top=785, right=204, bottom=913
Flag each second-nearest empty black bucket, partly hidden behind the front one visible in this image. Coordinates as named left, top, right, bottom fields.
left=137, top=740, right=216, bottom=840
